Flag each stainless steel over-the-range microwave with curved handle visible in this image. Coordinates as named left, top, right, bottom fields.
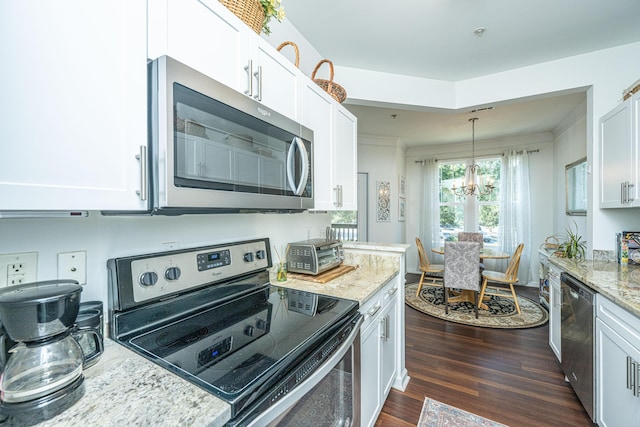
left=148, top=56, right=313, bottom=214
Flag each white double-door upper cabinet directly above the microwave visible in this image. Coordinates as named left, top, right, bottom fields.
left=148, top=0, right=302, bottom=119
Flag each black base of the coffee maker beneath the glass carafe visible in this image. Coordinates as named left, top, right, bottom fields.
left=0, top=375, right=85, bottom=426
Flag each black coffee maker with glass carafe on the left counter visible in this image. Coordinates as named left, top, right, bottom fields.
left=0, top=280, right=102, bottom=419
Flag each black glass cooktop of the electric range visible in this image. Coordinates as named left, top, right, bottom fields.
left=124, top=285, right=358, bottom=416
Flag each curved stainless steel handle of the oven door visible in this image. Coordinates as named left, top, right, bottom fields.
left=248, top=315, right=363, bottom=427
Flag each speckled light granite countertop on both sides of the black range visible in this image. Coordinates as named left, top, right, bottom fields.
left=5, top=249, right=408, bottom=427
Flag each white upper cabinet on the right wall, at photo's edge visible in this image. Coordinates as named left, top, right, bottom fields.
left=600, top=93, right=640, bottom=208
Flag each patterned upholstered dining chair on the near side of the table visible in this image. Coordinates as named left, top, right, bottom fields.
left=443, top=242, right=480, bottom=319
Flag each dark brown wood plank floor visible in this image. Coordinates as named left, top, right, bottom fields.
left=376, top=274, right=595, bottom=427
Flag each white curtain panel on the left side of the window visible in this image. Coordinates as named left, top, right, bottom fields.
left=419, top=160, right=440, bottom=260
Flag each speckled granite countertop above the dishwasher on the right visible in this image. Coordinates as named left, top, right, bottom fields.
left=549, top=255, right=640, bottom=317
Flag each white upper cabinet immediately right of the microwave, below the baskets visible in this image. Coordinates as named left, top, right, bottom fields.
left=302, top=80, right=358, bottom=210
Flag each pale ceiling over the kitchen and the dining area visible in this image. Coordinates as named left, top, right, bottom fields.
left=283, top=0, right=640, bottom=148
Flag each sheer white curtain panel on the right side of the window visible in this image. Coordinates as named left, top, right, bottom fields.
left=500, top=150, right=531, bottom=285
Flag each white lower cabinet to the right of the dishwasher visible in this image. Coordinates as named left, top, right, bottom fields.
left=595, top=296, right=640, bottom=427
